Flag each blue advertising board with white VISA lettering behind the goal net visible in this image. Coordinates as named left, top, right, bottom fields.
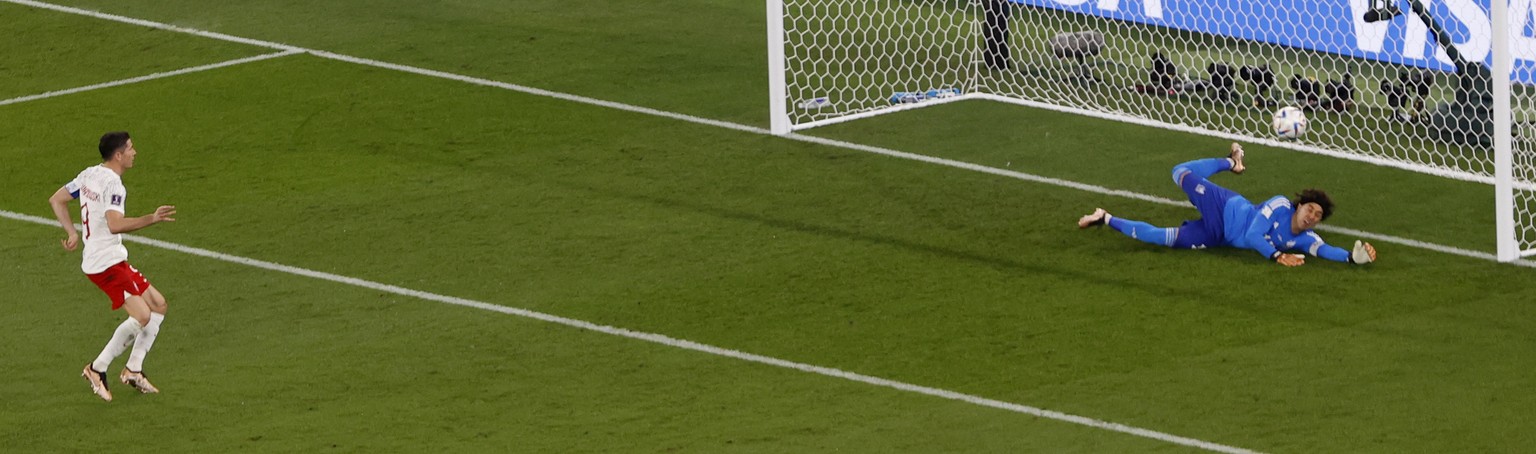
left=1011, top=0, right=1536, bottom=83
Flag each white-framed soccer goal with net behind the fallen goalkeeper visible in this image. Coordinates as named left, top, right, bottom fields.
left=766, top=0, right=1536, bottom=261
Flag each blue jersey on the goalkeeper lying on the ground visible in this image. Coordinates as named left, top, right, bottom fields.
left=1221, top=195, right=1349, bottom=262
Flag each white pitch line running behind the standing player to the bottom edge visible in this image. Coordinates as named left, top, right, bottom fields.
left=0, top=210, right=1255, bottom=454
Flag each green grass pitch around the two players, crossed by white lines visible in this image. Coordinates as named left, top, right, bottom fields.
left=0, top=0, right=1536, bottom=452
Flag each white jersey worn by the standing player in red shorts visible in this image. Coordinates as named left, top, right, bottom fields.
left=65, top=166, right=127, bottom=275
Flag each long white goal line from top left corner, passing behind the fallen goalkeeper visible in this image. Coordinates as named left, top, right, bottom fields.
left=0, top=0, right=1536, bottom=268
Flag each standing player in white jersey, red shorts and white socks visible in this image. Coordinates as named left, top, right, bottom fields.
left=48, top=132, right=177, bottom=402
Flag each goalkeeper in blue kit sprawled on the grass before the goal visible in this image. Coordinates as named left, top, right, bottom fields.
left=1077, top=143, right=1376, bottom=267
